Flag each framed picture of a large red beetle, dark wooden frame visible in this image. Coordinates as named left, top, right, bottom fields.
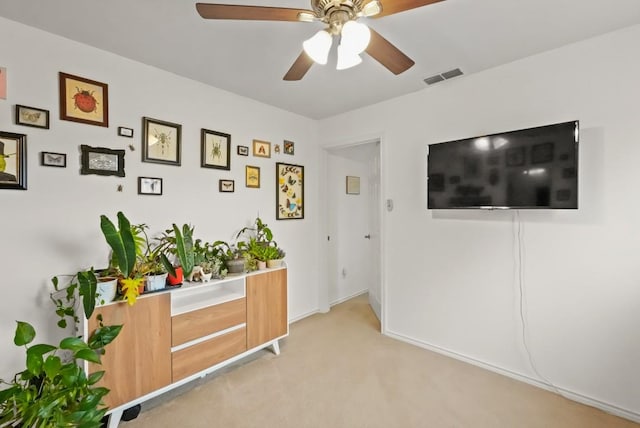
left=59, top=72, right=109, bottom=127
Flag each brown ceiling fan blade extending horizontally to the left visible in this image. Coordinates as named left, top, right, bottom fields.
left=196, top=3, right=313, bottom=22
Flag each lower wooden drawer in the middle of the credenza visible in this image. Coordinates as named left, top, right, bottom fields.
left=171, top=327, right=247, bottom=382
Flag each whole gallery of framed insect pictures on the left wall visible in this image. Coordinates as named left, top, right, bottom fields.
left=0, top=67, right=304, bottom=220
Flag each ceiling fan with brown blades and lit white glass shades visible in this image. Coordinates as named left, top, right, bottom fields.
left=196, top=0, right=443, bottom=80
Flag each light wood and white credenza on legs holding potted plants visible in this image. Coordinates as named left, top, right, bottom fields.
left=85, top=268, right=289, bottom=428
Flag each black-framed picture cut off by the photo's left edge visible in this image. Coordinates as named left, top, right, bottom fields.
left=0, top=131, right=27, bottom=190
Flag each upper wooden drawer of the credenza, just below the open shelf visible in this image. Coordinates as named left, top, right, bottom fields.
left=171, top=298, right=247, bottom=346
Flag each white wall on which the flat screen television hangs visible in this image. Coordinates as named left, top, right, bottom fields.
left=321, top=26, right=640, bottom=419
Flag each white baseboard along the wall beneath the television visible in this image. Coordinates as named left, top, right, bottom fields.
left=383, top=330, right=640, bottom=422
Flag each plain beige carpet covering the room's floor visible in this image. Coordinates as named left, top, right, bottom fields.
left=121, top=296, right=640, bottom=428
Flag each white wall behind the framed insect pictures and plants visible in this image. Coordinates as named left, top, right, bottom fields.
left=0, top=18, right=319, bottom=378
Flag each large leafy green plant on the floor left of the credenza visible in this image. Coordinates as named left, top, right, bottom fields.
left=0, top=271, right=122, bottom=428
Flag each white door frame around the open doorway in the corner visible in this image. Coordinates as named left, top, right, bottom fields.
left=318, top=135, right=387, bottom=334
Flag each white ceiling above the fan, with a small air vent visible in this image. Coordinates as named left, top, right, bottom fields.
left=0, top=0, right=640, bottom=119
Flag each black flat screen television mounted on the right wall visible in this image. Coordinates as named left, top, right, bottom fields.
left=427, top=120, right=579, bottom=209
